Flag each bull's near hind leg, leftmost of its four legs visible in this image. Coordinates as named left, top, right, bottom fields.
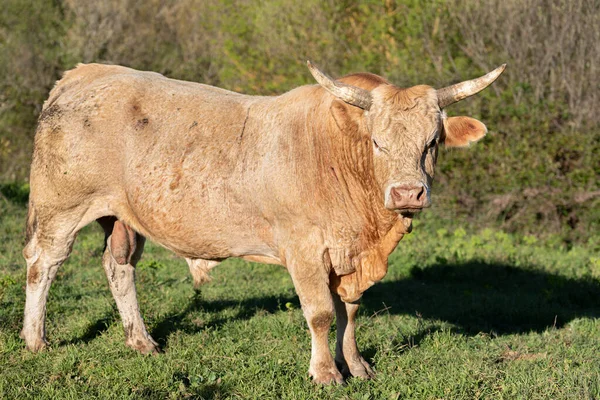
left=21, top=202, right=83, bottom=352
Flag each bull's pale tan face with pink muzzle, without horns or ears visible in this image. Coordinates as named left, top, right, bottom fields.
left=365, top=85, right=442, bottom=212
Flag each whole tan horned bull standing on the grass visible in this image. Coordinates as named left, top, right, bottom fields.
left=22, top=63, right=504, bottom=383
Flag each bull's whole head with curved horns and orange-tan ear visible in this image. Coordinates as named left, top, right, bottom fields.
left=308, top=61, right=506, bottom=214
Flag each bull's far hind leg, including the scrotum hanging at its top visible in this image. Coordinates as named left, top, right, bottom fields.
left=98, top=217, right=158, bottom=354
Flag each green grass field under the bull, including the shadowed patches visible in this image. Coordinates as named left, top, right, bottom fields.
left=0, top=197, right=600, bottom=399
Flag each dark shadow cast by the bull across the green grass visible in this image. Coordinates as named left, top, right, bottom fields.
left=152, top=261, right=600, bottom=344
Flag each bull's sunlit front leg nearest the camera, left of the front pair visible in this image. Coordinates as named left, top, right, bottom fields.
left=288, top=263, right=344, bottom=384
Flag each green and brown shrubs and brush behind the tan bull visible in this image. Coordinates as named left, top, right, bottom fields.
left=0, top=0, right=600, bottom=242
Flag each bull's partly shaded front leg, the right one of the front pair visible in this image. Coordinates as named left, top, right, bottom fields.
left=332, top=293, right=375, bottom=379
